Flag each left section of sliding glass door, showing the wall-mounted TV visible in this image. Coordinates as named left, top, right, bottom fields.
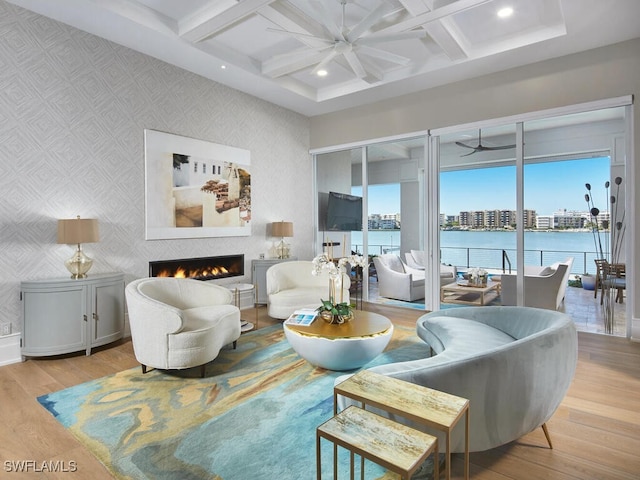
left=315, top=136, right=426, bottom=309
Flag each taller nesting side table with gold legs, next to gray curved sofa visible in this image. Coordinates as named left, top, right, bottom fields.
left=333, top=370, right=469, bottom=480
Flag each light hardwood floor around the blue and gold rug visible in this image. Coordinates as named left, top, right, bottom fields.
left=0, top=304, right=640, bottom=480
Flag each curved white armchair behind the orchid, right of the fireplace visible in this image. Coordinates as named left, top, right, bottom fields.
left=267, top=260, right=351, bottom=320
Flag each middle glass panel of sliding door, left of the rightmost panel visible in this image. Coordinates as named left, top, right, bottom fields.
left=439, top=125, right=517, bottom=288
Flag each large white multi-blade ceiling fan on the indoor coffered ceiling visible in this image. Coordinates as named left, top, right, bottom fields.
left=268, top=0, right=426, bottom=78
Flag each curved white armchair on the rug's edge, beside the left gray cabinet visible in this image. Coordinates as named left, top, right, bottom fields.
left=125, top=278, right=240, bottom=376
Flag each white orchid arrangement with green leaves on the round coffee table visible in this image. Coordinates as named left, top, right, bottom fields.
left=311, top=253, right=367, bottom=324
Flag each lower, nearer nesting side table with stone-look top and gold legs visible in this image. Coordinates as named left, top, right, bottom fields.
left=316, top=406, right=439, bottom=480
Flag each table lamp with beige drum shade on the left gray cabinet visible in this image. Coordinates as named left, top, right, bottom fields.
left=58, top=215, right=100, bottom=279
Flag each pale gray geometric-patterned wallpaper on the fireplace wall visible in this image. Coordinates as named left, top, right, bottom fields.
left=0, top=0, right=313, bottom=332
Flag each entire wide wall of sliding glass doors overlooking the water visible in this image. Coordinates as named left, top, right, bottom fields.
left=312, top=97, right=633, bottom=336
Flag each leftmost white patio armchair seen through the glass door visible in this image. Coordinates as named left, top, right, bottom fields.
left=373, top=254, right=424, bottom=302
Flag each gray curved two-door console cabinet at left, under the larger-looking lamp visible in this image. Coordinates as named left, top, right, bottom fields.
left=20, top=273, right=125, bottom=357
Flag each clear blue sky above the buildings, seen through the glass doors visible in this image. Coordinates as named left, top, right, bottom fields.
left=353, top=157, right=611, bottom=215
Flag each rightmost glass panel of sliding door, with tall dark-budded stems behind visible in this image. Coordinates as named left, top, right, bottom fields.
left=523, top=107, right=626, bottom=335
